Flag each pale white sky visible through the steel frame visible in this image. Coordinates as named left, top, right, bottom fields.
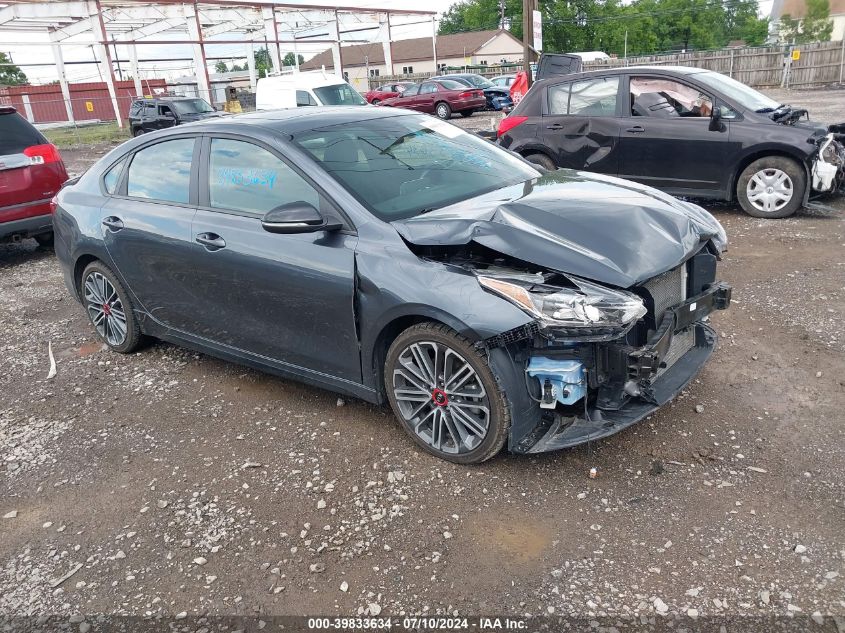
left=0, top=0, right=772, bottom=83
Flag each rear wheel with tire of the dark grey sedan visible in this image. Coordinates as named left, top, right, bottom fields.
left=80, top=261, right=141, bottom=354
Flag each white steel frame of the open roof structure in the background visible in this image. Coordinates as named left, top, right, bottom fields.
left=0, top=0, right=436, bottom=126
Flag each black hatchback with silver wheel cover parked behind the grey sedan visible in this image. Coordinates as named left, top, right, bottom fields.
left=498, top=66, right=845, bottom=218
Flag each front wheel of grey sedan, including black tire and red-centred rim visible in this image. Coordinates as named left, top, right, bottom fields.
left=384, top=323, right=510, bottom=464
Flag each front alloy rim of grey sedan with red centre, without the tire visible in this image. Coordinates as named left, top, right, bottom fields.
left=393, top=341, right=490, bottom=454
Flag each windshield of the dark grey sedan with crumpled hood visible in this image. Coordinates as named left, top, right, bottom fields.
left=293, top=115, right=540, bottom=222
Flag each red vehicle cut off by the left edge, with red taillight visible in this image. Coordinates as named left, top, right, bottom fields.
left=0, top=105, right=67, bottom=246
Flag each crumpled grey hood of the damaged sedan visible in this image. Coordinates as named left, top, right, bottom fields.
left=392, top=170, right=727, bottom=288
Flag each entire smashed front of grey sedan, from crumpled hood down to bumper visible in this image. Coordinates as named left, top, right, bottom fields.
left=393, top=172, right=731, bottom=453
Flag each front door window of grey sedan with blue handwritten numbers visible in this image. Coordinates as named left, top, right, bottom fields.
left=208, top=138, right=320, bottom=215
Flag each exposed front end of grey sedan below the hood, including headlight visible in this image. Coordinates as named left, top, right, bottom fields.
left=452, top=242, right=731, bottom=453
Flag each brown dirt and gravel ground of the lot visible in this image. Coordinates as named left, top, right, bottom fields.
left=0, top=86, right=845, bottom=630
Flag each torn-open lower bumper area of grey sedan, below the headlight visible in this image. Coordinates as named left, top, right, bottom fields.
left=484, top=274, right=731, bottom=453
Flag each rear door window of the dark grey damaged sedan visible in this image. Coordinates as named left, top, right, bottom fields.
left=126, top=138, right=194, bottom=204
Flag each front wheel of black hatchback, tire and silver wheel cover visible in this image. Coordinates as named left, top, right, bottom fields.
left=736, top=156, right=807, bottom=218
